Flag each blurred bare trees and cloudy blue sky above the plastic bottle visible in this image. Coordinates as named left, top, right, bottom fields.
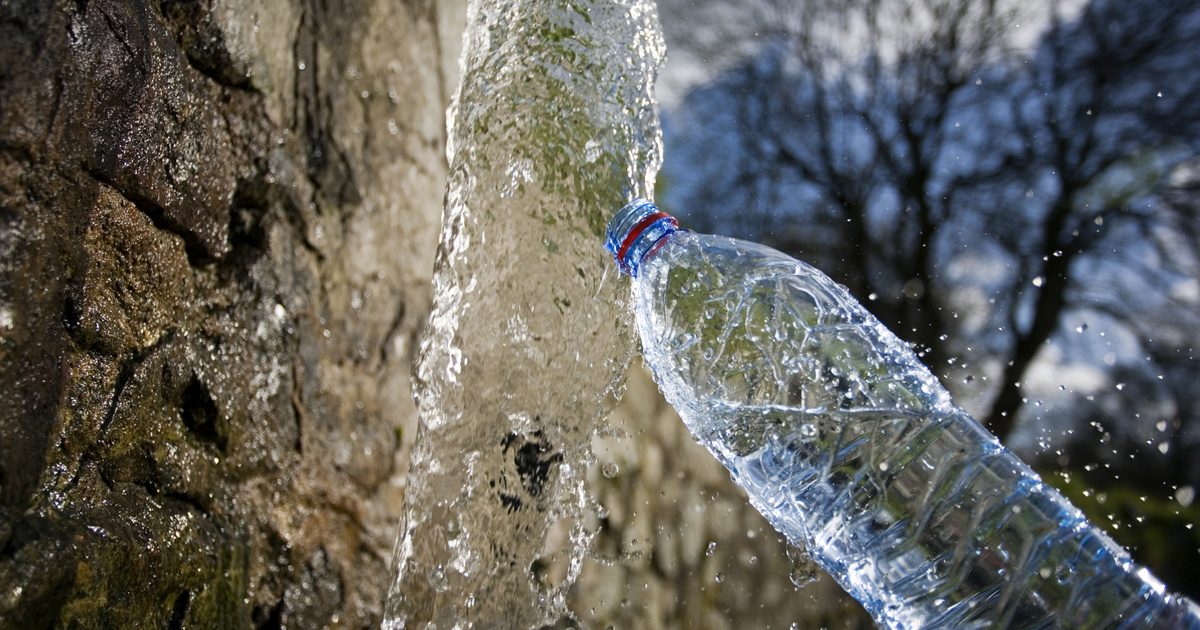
left=661, top=0, right=1200, bottom=595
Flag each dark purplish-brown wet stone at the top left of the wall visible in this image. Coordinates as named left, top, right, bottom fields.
left=56, top=1, right=236, bottom=259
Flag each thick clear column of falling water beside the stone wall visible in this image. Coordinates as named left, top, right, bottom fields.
left=384, top=0, right=662, bottom=628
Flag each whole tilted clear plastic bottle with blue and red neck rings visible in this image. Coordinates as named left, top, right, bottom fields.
left=606, top=200, right=1200, bottom=629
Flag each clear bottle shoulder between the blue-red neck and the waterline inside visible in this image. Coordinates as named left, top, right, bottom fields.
left=635, top=230, right=949, bottom=436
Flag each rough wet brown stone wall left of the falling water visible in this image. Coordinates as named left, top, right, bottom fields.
left=0, top=0, right=464, bottom=628
